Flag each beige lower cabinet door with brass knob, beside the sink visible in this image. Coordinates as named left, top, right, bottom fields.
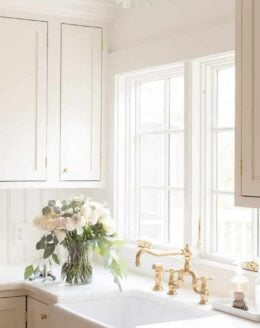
left=27, top=297, right=50, bottom=328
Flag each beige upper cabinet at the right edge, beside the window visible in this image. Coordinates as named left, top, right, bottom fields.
left=236, top=0, right=260, bottom=207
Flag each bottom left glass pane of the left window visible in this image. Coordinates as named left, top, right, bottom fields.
left=140, top=189, right=164, bottom=222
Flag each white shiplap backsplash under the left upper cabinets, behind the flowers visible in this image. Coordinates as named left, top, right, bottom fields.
left=0, top=189, right=106, bottom=264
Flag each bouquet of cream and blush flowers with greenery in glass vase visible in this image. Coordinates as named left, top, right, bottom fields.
left=24, top=196, right=125, bottom=289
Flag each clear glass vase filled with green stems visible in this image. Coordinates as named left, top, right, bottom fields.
left=61, top=240, right=92, bottom=285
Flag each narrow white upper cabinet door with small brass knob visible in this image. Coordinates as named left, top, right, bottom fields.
left=60, top=24, right=102, bottom=181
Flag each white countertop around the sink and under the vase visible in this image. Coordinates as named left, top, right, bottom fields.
left=0, top=266, right=260, bottom=328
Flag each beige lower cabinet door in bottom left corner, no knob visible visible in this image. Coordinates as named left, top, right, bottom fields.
left=0, top=297, right=26, bottom=328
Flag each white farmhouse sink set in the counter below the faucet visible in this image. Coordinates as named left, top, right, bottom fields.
left=54, top=290, right=214, bottom=328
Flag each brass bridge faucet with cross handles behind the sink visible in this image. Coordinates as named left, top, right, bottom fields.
left=135, top=241, right=211, bottom=304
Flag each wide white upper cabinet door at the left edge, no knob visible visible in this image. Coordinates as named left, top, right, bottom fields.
left=0, top=18, right=47, bottom=181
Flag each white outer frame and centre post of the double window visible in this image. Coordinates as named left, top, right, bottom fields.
left=114, top=51, right=260, bottom=264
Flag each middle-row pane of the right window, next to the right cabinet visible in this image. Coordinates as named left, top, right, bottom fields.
left=216, top=131, right=235, bottom=192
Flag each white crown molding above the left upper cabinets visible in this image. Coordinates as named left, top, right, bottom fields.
left=0, top=0, right=116, bottom=23
